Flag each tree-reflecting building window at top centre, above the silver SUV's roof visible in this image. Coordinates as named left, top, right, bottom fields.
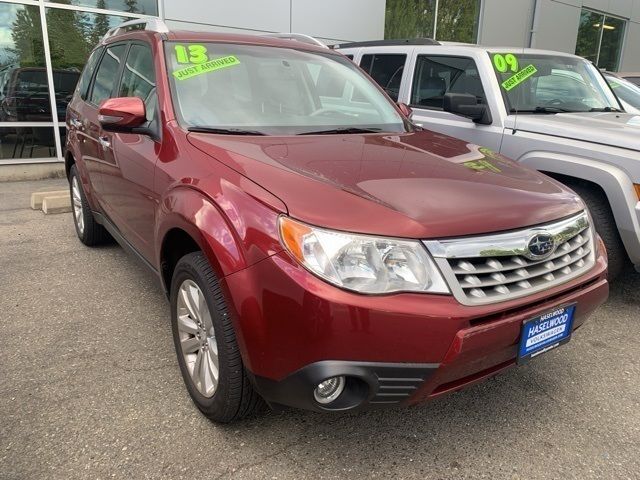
left=384, top=0, right=481, bottom=43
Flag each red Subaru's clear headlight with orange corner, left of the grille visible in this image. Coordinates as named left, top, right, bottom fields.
left=280, top=217, right=449, bottom=294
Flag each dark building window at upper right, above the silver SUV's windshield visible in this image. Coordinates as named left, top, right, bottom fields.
left=576, top=8, right=626, bottom=72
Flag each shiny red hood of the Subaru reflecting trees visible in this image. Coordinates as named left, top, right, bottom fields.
left=188, top=131, right=583, bottom=239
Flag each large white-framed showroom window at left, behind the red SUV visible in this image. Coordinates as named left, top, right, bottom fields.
left=0, top=0, right=158, bottom=164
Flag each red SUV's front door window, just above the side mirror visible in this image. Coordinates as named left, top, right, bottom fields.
left=118, top=43, right=157, bottom=121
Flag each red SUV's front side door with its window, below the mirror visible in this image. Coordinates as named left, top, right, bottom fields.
left=101, top=41, right=161, bottom=262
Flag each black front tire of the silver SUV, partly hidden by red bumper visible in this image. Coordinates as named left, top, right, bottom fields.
left=569, top=184, right=631, bottom=280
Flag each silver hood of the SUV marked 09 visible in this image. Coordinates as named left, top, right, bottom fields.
left=506, top=112, right=640, bottom=151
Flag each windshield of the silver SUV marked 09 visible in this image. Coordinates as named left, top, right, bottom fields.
left=490, top=52, right=620, bottom=113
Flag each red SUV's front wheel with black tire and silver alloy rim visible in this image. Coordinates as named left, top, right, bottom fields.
left=171, top=252, right=263, bottom=423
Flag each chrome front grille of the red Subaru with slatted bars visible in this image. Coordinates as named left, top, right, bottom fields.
left=424, top=212, right=595, bottom=305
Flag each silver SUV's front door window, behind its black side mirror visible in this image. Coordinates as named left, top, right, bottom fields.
left=411, top=55, right=487, bottom=109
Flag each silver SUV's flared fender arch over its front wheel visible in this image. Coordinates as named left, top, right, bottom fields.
left=519, top=152, right=640, bottom=265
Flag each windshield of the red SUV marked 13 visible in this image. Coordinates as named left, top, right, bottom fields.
left=165, top=42, right=406, bottom=135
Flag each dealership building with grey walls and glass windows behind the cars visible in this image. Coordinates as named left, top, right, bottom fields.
left=0, top=0, right=640, bottom=172
